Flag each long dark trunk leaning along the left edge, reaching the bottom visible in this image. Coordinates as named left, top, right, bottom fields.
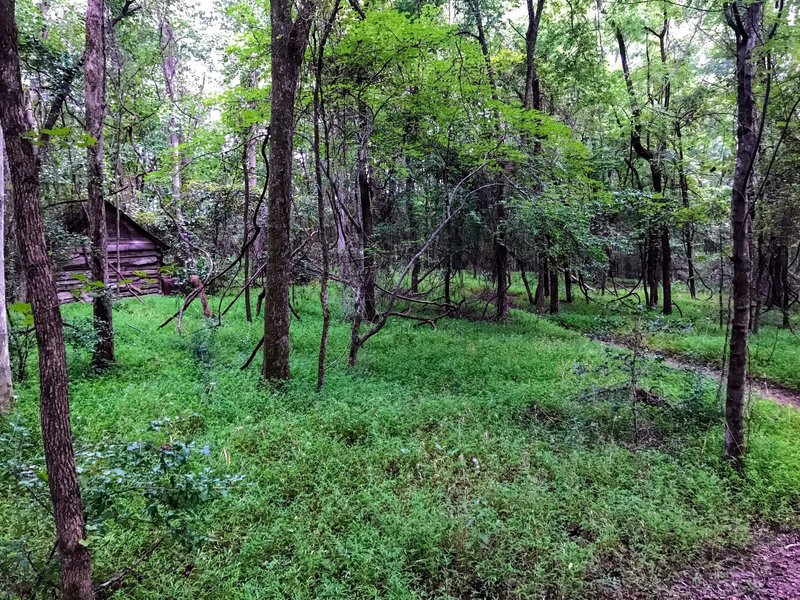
left=0, top=0, right=94, bottom=600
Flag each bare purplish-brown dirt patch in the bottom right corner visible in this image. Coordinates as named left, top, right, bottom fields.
left=665, top=533, right=800, bottom=600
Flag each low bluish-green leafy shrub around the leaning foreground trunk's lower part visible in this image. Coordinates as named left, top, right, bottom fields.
left=0, top=421, right=243, bottom=597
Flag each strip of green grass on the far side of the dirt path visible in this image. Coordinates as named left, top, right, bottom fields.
left=536, top=286, right=800, bottom=390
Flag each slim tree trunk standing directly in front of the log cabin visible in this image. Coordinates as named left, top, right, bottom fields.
left=83, top=0, right=114, bottom=370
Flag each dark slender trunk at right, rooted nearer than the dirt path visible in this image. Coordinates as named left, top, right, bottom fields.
left=725, top=0, right=763, bottom=470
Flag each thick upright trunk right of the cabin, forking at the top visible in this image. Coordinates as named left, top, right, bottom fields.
left=261, top=0, right=314, bottom=381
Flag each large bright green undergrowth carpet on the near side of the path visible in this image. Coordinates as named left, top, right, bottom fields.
left=0, top=288, right=800, bottom=600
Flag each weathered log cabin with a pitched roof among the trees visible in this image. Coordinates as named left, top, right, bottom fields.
left=56, top=201, right=167, bottom=303
